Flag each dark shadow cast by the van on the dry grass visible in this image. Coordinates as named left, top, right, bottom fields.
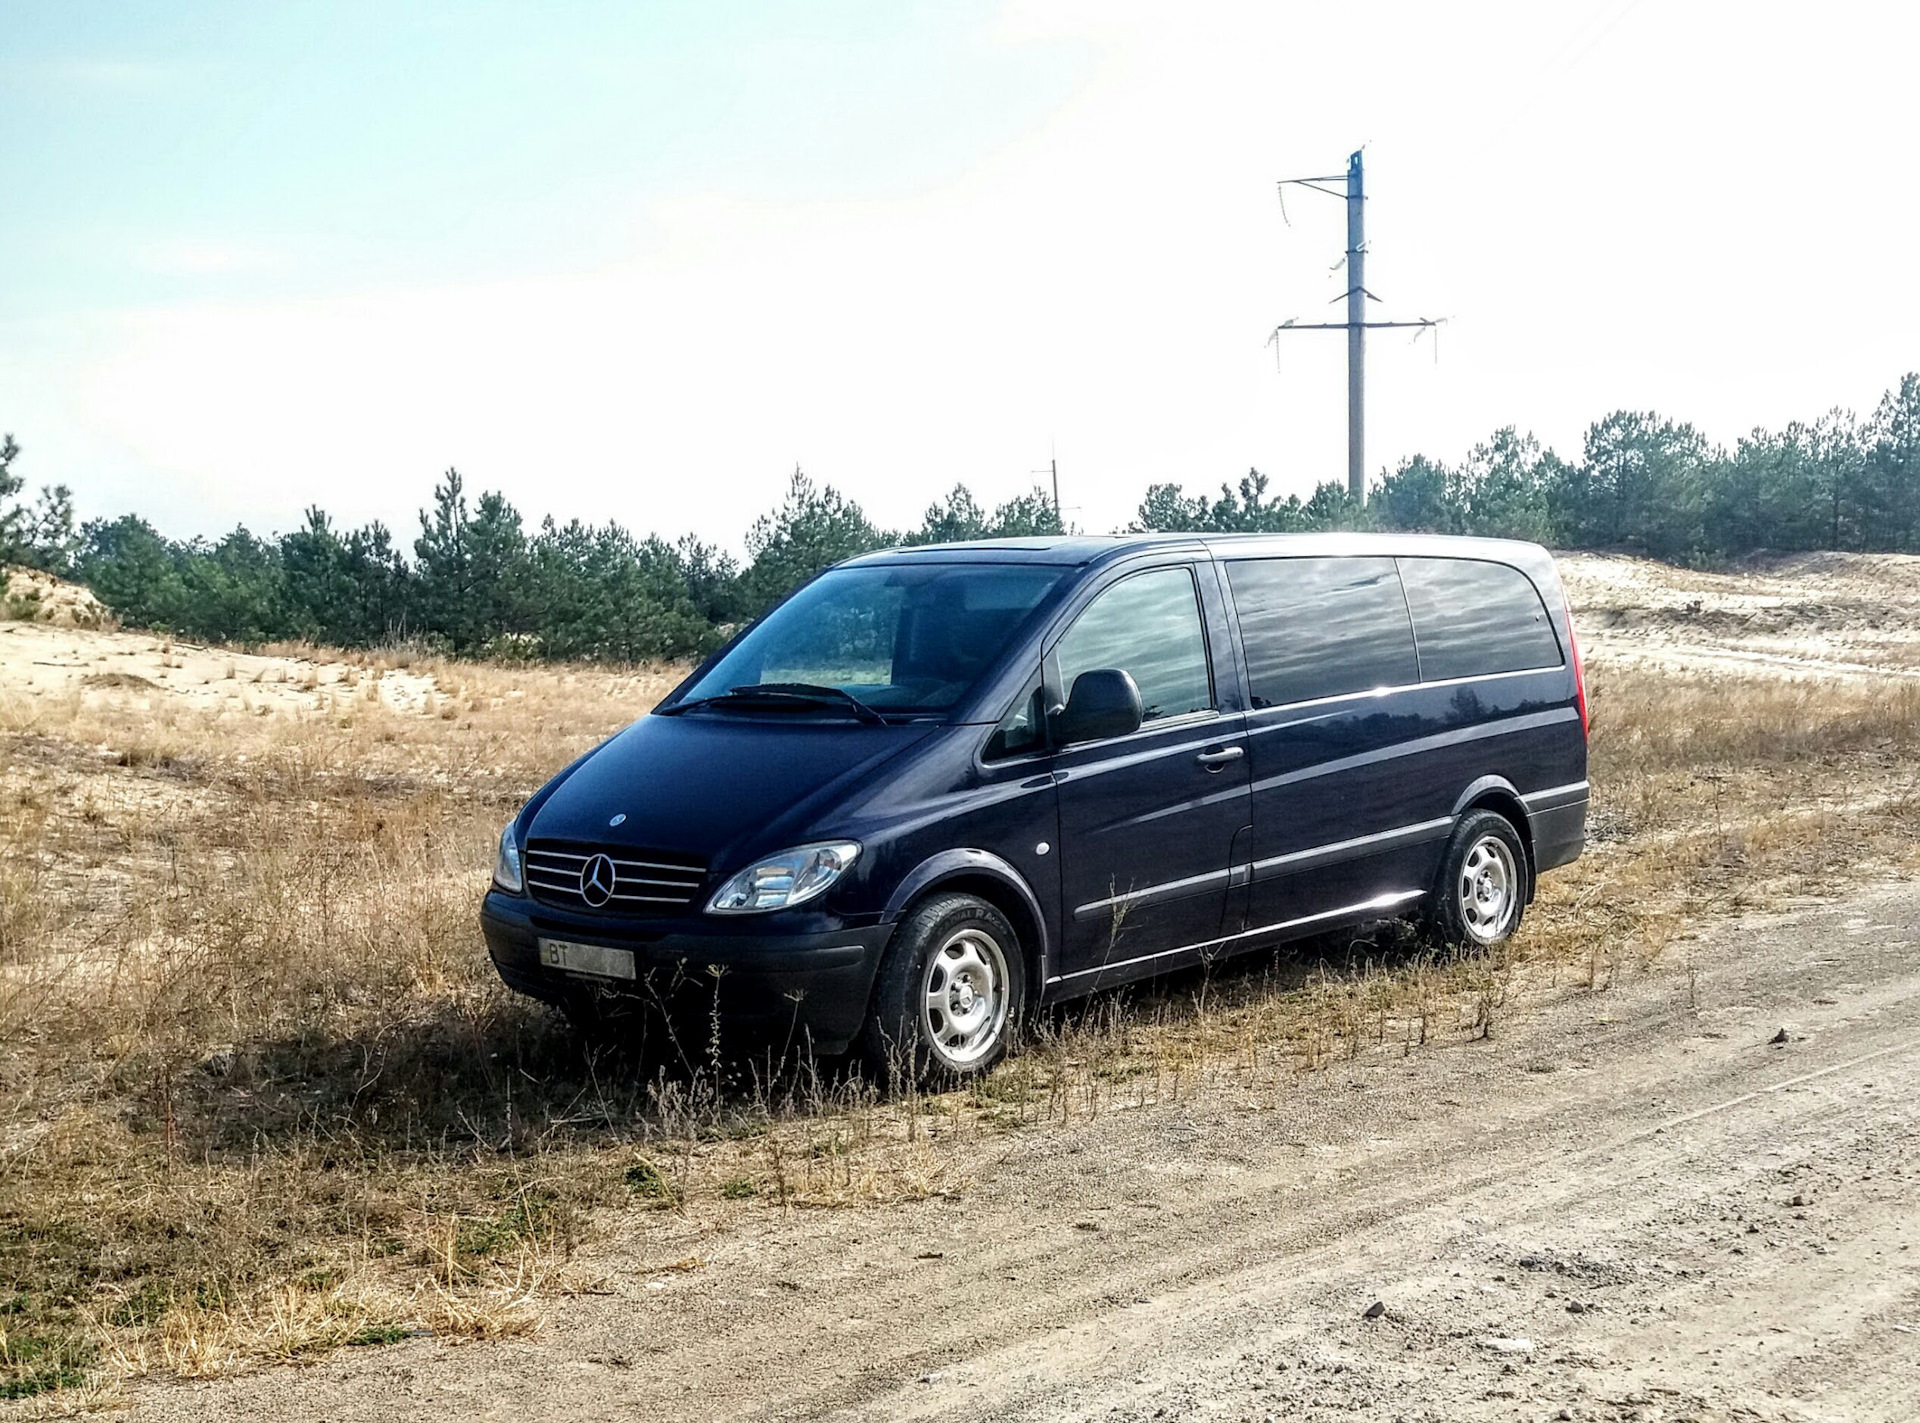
left=176, top=926, right=1430, bottom=1158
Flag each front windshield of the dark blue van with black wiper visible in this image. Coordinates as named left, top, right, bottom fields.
left=682, top=563, right=1066, bottom=712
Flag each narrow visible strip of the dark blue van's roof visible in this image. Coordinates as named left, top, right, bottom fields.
left=847, top=534, right=1549, bottom=565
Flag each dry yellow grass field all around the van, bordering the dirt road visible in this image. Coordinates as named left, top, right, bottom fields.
left=0, top=610, right=1920, bottom=1402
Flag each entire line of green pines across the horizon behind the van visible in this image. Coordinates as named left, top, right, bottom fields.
left=0, top=374, right=1920, bottom=663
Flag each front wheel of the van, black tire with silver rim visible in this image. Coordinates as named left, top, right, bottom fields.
left=860, top=895, right=1027, bottom=1083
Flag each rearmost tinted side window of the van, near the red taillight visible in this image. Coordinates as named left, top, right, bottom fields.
left=1400, top=559, right=1561, bottom=682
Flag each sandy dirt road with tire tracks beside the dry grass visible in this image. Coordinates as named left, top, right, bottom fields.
left=132, top=885, right=1920, bottom=1423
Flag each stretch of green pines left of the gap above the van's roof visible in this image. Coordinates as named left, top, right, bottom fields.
left=0, top=449, right=1060, bottom=663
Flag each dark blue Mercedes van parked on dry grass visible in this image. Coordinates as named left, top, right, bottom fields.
left=480, top=534, right=1588, bottom=1075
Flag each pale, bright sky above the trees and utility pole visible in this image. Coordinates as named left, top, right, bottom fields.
left=0, top=0, right=1920, bottom=549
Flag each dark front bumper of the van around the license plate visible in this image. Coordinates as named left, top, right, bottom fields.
left=480, top=889, right=893, bottom=1054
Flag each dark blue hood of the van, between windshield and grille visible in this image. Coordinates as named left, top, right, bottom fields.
left=526, top=712, right=937, bottom=870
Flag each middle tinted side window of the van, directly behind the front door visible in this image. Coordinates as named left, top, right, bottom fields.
left=1227, top=559, right=1421, bottom=707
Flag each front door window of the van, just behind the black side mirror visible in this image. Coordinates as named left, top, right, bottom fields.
left=1054, top=568, right=1213, bottom=722
